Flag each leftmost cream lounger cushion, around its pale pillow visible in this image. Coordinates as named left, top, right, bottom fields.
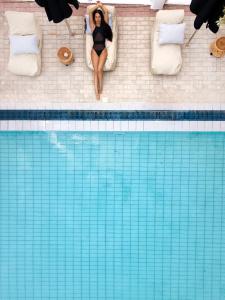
left=5, top=11, right=42, bottom=76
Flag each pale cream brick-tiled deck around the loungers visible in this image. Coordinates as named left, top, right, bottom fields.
left=0, top=3, right=225, bottom=109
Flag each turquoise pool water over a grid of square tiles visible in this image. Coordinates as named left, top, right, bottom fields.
left=0, top=132, right=225, bottom=300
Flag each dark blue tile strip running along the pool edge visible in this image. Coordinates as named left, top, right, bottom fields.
left=0, top=110, right=225, bottom=121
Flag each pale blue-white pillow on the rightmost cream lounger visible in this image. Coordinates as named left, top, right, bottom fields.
left=159, top=23, right=185, bottom=45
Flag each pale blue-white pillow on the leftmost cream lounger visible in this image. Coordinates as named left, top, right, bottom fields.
left=9, top=35, right=39, bottom=55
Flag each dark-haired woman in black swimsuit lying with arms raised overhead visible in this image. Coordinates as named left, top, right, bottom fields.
left=89, top=1, right=112, bottom=100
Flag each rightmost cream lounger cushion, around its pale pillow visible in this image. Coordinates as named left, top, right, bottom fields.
left=151, top=10, right=184, bottom=75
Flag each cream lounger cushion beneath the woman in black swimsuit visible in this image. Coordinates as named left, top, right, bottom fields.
left=86, top=5, right=118, bottom=71
